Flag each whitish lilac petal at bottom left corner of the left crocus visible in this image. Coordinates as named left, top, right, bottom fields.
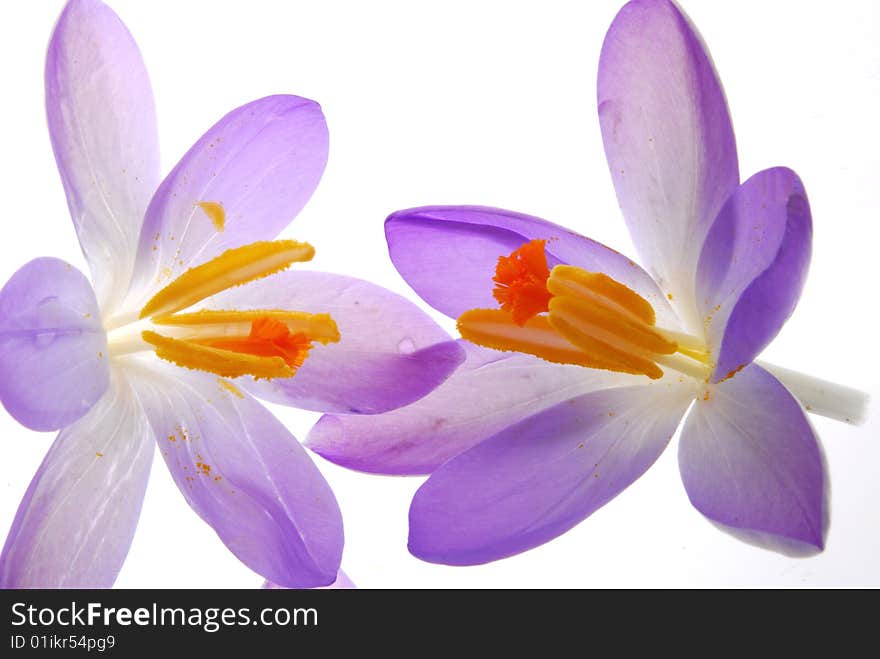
left=0, top=373, right=154, bottom=588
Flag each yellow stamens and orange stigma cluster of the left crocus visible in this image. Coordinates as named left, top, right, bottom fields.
left=108, top=240, right=340, bottom=378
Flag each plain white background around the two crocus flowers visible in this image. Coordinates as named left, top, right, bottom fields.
left=0, top=0, right=880, bottom=587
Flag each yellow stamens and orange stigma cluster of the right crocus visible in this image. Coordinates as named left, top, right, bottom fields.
left=458, top=240, right=709, bottom=379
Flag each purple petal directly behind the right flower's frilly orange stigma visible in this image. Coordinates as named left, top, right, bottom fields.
left=385, top=206, right=677, bottom=326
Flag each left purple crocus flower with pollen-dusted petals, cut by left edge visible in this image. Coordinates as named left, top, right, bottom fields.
left=0, top=0, right=462, bottom=587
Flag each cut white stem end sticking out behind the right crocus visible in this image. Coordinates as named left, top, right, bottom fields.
left=756, top=361, right=870, bottom=425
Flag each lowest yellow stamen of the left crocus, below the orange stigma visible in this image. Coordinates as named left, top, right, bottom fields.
left=141, top=330, right=295, bottom=379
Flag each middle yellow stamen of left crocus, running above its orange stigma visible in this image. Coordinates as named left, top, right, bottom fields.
left=153, top=309, right=340, bottom=345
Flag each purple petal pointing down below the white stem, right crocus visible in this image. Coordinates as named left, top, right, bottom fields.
left=678, top=364, right=828, bottom=554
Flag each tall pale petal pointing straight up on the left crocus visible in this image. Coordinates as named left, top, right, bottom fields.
left=46, top=0, right=159, bottom=310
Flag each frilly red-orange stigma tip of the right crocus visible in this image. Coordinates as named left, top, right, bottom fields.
left=492, top=240, right=553, bottom=326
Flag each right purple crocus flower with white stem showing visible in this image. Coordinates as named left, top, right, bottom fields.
left=307, top=0, right=864, bottom=565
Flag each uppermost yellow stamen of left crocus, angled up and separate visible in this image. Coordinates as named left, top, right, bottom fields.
left=140, top=240, right=315, bottom=318
